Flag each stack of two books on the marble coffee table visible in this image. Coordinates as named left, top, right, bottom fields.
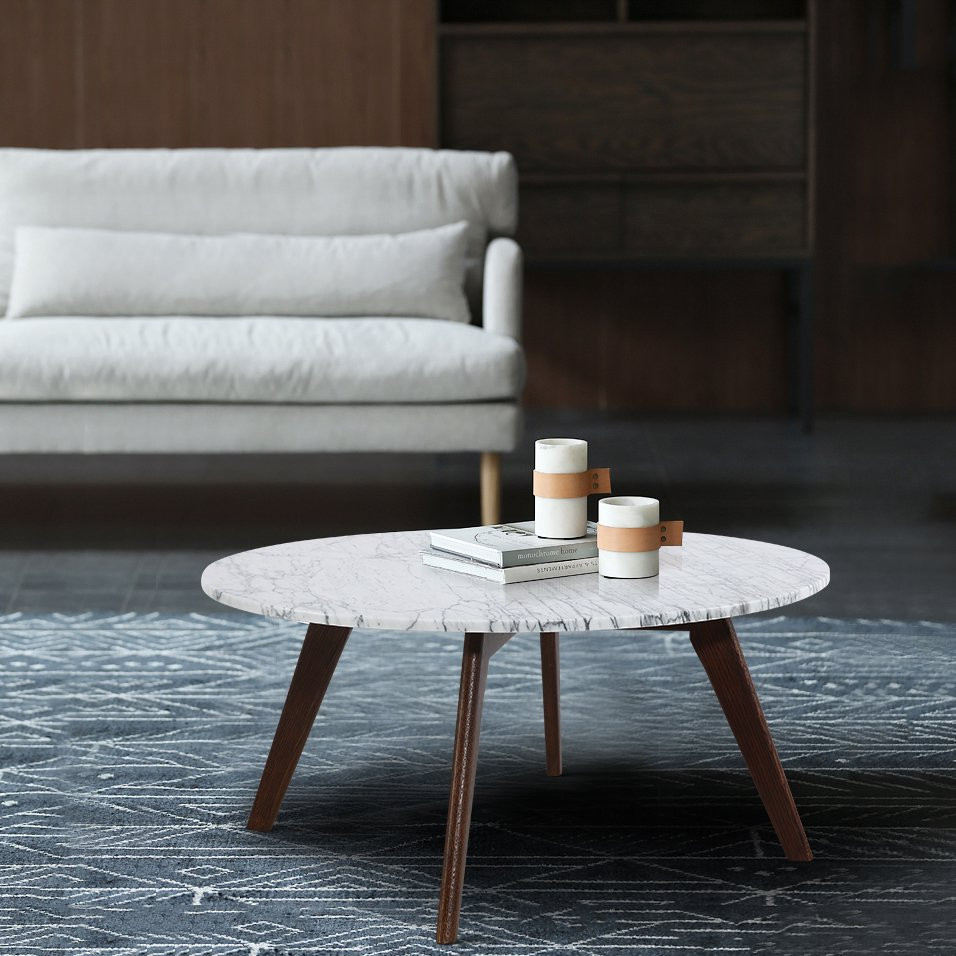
left=422, top=521, right=597, bottom=584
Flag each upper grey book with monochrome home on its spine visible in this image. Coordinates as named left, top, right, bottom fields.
left=431, top=521, right=597, bottom=568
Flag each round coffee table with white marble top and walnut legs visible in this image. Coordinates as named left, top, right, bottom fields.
left=202, top=531, right=830, bottom=943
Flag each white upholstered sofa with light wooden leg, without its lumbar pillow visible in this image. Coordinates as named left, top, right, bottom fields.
left=0, top=148, right=524, bottom=521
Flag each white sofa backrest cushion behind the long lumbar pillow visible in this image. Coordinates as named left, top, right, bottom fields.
left=0, top=148, right=517, bottom=312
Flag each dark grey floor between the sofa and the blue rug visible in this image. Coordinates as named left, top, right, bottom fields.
left=0, top=413, right=956, bottom=621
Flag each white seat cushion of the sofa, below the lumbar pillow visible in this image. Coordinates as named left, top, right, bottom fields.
left=0, top=316, right=524, bottom=404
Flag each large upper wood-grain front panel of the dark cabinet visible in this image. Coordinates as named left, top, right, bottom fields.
left=441, top=30, right=806, bottom=170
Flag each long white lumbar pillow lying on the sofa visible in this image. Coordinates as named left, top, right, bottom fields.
left=7, top=222, right=470, bottom=322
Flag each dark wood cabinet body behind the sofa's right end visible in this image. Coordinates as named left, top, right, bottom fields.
left=439, top=3, right=813, bottom=262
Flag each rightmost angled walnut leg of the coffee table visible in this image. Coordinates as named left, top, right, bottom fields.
left=690, top=620, right=813, bottom=862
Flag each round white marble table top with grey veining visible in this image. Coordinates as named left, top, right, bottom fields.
left=202, top=531, right=830, bottom=633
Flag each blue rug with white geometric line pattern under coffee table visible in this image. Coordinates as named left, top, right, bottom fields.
left=0, top=614, right=956, bottom=956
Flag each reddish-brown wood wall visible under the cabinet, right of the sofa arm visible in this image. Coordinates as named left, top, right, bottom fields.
left=524, top=267, right=787, bottom=412
